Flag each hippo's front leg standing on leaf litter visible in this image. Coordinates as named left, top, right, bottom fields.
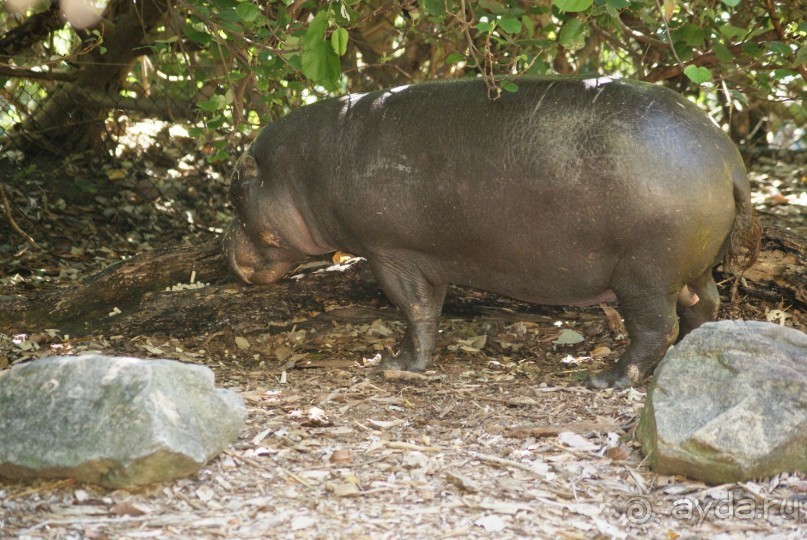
left=370, top=259, right=447, bottom=371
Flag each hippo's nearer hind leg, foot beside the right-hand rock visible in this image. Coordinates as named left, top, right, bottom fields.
left=588, top=290, right=678, bottom=388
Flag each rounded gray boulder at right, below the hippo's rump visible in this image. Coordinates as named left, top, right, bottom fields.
left=637, top=321, right=807, bottom=484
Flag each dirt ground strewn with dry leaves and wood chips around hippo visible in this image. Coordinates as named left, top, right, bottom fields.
left=0, top=132, right=807, bottom=540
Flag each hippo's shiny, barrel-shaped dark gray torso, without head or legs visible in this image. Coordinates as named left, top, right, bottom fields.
left=288, top=78, right=743, bottom=303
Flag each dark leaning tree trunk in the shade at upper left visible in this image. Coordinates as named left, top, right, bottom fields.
left=10, top=0, right=169, bottom=156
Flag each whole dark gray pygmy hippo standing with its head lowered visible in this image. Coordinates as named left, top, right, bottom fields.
left=224, top=78, right=750, bottom=388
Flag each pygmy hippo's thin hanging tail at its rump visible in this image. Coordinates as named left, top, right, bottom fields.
left=723, top=167, right=762, bottom=274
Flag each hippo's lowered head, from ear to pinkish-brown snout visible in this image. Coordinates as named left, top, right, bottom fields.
left=222, top=152, right=305, bottom=284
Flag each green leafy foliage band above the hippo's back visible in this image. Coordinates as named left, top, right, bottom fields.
left=0, top=0, right=807, bottom=159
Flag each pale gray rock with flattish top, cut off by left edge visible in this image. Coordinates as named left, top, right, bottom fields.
left=0, top=355, right=246, bottom=488
